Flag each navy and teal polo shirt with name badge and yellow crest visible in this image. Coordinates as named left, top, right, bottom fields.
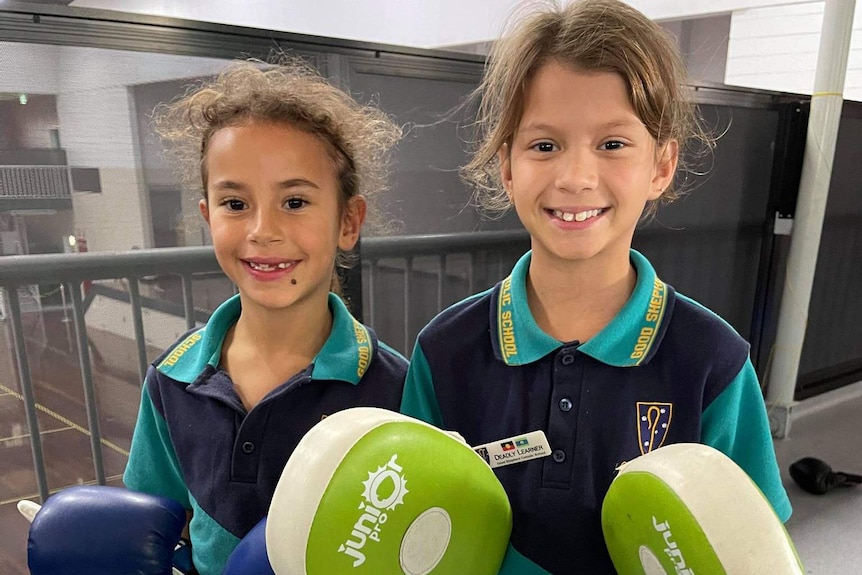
left=401, top=250, right=790, bottom=575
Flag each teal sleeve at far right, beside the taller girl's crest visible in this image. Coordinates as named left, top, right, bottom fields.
left=701, top=360, right=792, bottom=521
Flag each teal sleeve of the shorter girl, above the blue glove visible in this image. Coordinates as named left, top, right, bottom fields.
left=123, top=384, right=191, bottom=509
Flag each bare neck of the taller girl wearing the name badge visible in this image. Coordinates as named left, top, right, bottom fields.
left=527, top=252, right=637, bottom=343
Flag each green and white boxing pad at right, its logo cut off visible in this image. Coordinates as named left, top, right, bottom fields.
left=602, top=443, right=805, bottom=575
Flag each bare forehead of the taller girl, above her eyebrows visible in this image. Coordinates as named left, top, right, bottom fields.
left=519, top=61, right=642, bottom=129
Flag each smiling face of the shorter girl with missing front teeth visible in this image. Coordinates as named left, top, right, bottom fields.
left=200, top=121, right=365, bottom=316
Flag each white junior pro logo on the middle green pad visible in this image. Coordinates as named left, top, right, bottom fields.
left=338, top=453, right=408, bottom=567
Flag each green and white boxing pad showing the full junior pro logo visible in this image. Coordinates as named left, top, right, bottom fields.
left=266, top=407, right=512, bottom=575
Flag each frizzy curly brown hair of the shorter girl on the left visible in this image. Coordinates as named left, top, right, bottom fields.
left=154, top=54, right=401, bottom=291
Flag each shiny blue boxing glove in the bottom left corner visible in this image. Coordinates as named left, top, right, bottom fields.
left=27, top=486, right=186, bottom=575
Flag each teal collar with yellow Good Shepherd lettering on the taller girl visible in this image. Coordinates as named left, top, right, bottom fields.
left=492, top=250, right=674, bottom=367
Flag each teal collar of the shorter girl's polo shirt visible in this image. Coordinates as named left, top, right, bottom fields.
left=156, top=293, right=377, bottom=384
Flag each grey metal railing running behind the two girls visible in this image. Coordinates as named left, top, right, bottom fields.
left=0, top=231, right=529, bottom=501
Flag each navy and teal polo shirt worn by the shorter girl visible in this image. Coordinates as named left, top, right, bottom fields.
left=123, top=294, right=407, bottom=575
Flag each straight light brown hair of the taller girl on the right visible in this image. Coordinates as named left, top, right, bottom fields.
left=461, top=0, right=714, bottom=217
